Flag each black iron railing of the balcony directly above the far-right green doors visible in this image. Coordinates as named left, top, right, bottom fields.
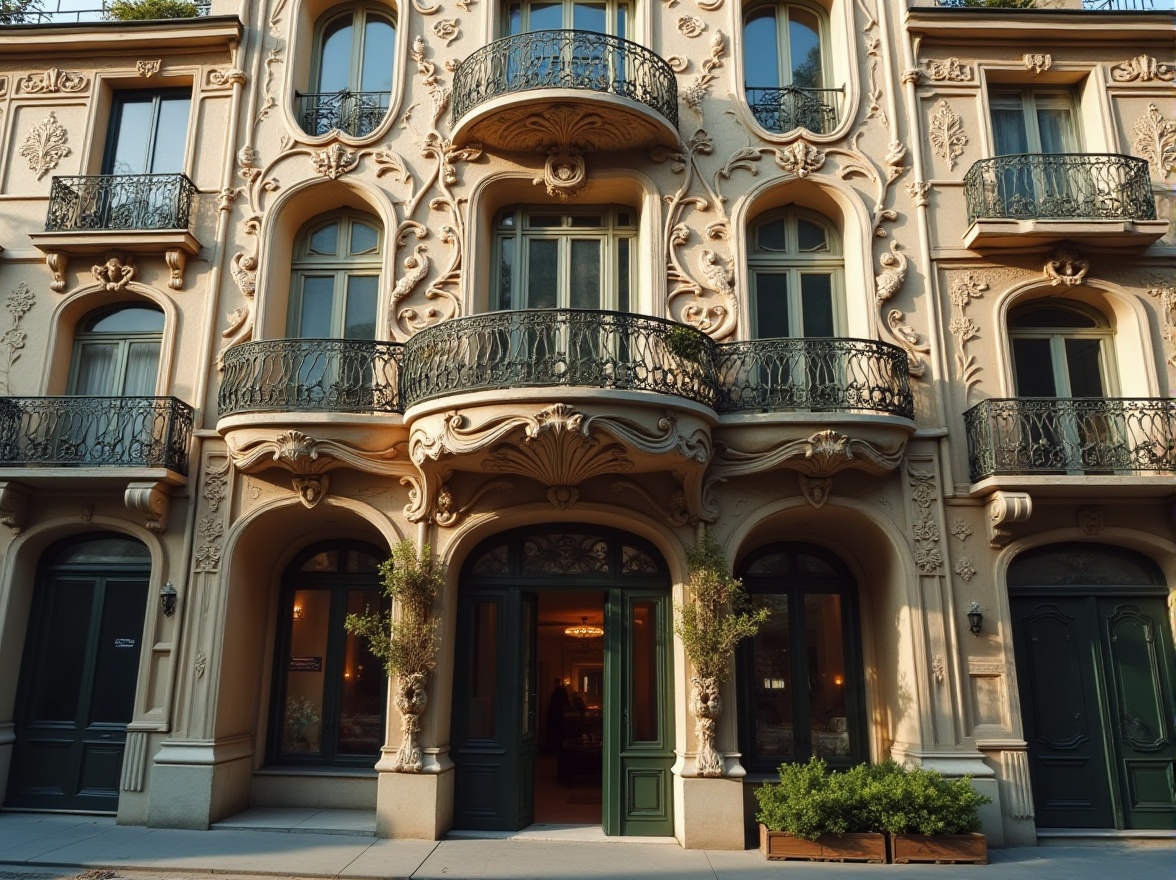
left=963, top=398, right=1176, bottom=482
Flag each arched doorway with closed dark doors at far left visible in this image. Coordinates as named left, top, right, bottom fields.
left=5, top=534, right=151, bottom=813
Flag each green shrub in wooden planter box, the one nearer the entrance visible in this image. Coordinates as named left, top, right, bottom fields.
left=755, top=758, right=886, bottom=864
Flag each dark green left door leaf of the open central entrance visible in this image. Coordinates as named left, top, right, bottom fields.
left=453, top=589, right=539, bottom=831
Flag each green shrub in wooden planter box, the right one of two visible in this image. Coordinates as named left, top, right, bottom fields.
left=867, top=761, right=990, bottom=865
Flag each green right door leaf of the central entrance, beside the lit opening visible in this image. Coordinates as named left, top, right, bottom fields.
left=603, top=589, right=674, bottom=836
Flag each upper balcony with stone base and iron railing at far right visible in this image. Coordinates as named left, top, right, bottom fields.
left=964, top=153, right=1168, bottom=247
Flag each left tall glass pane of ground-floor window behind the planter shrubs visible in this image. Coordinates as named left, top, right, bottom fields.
left=749, top=594, right=796, bottom=759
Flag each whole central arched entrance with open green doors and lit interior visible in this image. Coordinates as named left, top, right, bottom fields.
left=450, top=525, right=674, bottom=835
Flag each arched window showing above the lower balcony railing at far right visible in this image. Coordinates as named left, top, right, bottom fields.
left=1009, top=299, right=1116, bottom=398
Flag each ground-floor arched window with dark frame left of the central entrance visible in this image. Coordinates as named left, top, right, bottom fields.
left=269, top=541, right=387, bottom=767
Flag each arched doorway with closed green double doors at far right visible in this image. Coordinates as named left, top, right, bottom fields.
left=1008, top=544, right=1176, bottom=828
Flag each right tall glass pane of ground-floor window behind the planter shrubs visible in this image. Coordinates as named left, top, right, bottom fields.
left=804, top=594, right=849, bottom=758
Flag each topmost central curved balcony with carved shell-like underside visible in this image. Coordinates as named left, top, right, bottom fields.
left=453, top=31, right=679, bottom=152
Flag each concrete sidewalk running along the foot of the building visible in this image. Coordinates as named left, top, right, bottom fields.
left=0, top=813, right=1176, bottom=880
